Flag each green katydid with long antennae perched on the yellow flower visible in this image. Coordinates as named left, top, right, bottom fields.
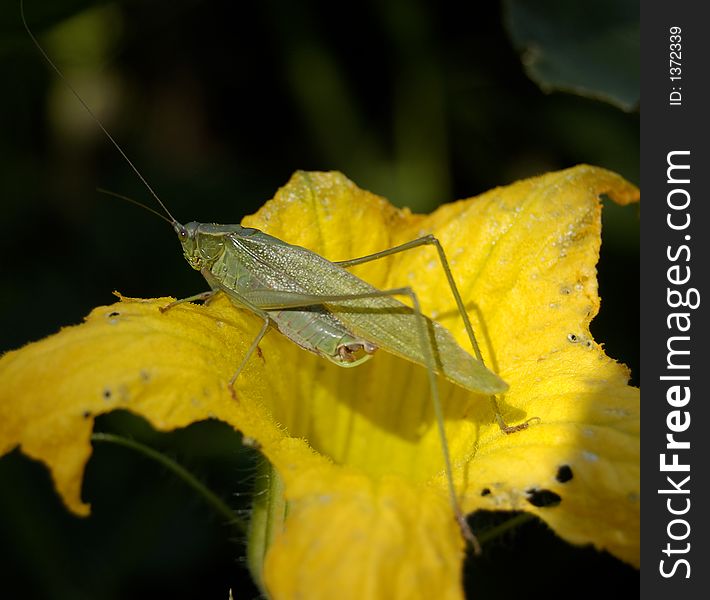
left=20, top=1, right=529, bottom=552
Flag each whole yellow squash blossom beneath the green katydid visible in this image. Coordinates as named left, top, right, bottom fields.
left=0, top=166, right=639, bottom=599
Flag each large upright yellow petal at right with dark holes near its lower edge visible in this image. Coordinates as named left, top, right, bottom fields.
left=426, top=166, right=639, bottom=565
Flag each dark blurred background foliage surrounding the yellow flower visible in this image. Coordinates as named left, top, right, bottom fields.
left=0, top=0, right=639, bottom=598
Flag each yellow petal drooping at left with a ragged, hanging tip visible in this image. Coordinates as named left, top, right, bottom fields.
left=0, top=298, right=266, bottom=514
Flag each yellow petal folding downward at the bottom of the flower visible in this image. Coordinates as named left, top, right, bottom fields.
left=264, top=466, right=463, bottom=599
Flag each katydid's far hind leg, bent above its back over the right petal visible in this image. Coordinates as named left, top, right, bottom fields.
left=335, top=234, right=537, bottom=433
